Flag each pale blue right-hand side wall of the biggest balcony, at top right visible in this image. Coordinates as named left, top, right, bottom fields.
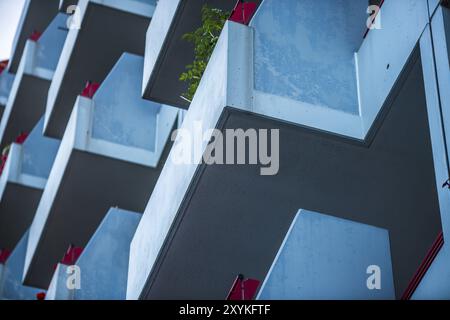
left=357, top=0, right=430, bottom=137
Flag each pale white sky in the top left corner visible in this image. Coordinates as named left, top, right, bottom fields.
left=0, top=0, right=25, bottom=61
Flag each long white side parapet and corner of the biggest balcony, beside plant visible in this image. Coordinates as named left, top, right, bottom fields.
left=127, top=22, right=253, bottom=300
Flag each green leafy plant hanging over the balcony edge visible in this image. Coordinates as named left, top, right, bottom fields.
left=180, top=5, right=230, bottom=102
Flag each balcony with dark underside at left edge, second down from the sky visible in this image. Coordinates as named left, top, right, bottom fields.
left=0, top=13, right=67, bottom=148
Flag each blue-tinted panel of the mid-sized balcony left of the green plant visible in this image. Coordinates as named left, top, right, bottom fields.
left=92, top=53, right=161, bottom=151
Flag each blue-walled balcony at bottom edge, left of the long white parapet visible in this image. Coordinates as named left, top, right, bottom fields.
left=46, top=208, right=141, bottom=300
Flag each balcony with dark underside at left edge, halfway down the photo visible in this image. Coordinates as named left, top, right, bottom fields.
left=0, top=118, right=60, bottom=251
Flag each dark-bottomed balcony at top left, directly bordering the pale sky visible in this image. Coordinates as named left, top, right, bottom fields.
left=8, top=0, right=60, bottom=74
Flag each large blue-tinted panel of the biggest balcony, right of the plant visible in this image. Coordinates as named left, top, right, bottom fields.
left=251, top=0, right=368, bottom=114
